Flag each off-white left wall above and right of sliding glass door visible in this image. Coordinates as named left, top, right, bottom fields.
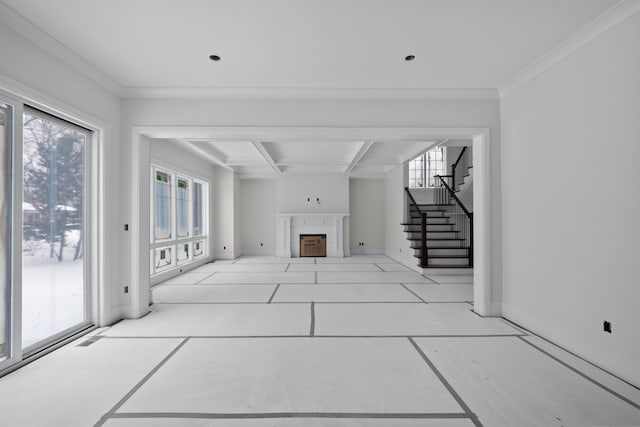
left=0, top=24, right=123, bottom=323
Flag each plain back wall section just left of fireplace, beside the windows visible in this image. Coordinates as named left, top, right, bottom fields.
left=238, top=178, right=277, bottom=255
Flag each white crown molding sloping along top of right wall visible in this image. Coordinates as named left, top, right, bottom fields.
left=498, top=0, right=640, bottom=98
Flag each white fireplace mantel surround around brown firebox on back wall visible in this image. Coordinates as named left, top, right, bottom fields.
left=276, top=213, right=349, bottom=258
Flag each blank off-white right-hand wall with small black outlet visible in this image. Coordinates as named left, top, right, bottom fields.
left=501, top=13, right=640, bottom=386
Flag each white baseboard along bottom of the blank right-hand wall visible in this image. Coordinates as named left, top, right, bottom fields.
left=501, top=303, right=640, bottom=387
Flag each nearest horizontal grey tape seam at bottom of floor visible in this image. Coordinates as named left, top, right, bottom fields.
left=111, top=412, right=470, bottom=420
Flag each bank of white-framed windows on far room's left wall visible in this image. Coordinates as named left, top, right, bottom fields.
left=151, top=166, right=208, bottom=275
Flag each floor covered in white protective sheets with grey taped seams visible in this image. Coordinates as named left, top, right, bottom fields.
left=0, top=256, right=640, bottom=427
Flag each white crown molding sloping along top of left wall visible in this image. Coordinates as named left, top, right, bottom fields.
left=0, top=1, right=124, bottom=97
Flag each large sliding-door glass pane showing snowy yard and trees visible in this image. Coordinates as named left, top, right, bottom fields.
left=22, top=110, right=88, bottom=349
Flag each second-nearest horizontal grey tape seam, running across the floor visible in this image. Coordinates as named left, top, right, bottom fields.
left=104, top=331, right=528, bottom=340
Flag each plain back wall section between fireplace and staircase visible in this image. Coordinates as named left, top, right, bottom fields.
left=349, top=177, right=385, bottom=254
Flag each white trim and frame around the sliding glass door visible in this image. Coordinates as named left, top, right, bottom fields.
left=0, top=77, right=112, bottom=378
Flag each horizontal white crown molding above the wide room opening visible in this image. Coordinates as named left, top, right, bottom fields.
left=123, top=87, right=498, bottom=100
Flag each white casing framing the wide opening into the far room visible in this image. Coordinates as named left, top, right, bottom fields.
left=130, top=126, right=493, bottom=318
